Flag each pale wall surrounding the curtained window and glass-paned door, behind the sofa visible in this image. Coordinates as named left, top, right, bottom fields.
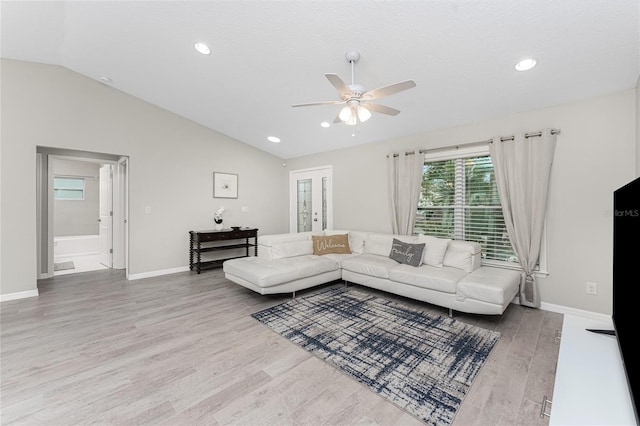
left=287, top=89, right=637, bottom=314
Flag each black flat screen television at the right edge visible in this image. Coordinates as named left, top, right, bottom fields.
left=612, top=177, right=640, bottom=424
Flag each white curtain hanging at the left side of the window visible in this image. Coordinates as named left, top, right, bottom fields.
left=387, top=149, right=424, bottom=235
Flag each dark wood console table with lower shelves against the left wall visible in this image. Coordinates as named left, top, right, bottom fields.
left=189, top=228, right=258, bottom=273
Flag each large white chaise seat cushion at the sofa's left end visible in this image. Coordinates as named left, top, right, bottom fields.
left=222, top=255, right=339, bottom=287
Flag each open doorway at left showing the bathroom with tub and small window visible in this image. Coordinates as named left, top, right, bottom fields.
left=37, top=147, right=128, bottom=278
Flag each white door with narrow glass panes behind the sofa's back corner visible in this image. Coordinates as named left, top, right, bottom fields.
left=289, top=166, right=333, bottom=232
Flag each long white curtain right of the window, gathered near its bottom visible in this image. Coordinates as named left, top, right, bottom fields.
left=489, top=129, right=556, bottom=308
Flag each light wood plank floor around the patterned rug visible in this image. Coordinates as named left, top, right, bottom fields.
left=0, top=269, right=562, bottom=426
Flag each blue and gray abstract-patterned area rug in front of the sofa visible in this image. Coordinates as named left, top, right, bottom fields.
left=252, top=286, right=500, bottom=425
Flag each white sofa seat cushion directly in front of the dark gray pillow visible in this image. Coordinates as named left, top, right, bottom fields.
left=389, top=265, right=467, bottom=293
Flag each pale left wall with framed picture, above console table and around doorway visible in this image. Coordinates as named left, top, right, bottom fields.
left=0, top=59, right=288, bottom=296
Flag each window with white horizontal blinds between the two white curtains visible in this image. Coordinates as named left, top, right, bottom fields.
left=414, top=154, right=519, bottom=266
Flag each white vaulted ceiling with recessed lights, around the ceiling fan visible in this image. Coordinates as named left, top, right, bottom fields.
left=0, top=0, right=640, bottom=159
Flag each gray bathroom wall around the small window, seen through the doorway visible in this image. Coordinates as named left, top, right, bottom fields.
left=53, top=160, right=100, bottom=237
